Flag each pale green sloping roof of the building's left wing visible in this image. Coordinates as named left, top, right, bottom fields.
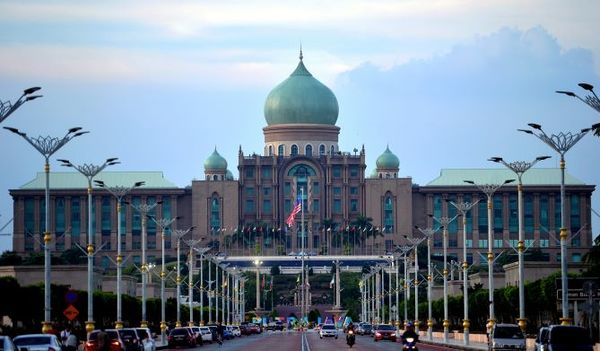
left=19, top=172, right=177, bottom=190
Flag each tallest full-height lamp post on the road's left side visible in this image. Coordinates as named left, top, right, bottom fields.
left=4, top=126, right=86, bottom=333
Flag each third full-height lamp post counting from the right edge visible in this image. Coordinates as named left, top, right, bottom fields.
left=464, top=179, right=515, bottom=331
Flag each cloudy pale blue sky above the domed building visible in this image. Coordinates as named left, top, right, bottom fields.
left=0, top=0, right=600, bottom=252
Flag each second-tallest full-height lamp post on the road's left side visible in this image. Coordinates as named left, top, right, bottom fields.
left=58, top=157, right=119, bottom=333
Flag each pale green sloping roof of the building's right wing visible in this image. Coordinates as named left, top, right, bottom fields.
left=427, top=168, right=586, bottom=186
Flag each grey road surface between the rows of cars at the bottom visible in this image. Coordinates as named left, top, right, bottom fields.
left=167, top=331, right=464, bottom=351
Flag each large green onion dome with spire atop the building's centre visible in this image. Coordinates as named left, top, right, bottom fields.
left=265, top=53, right=339, bottom=125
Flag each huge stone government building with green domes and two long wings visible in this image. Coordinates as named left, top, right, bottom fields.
left=5, top=55, right=595, bottom=268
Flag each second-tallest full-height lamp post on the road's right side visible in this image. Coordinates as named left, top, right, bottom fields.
left=489, top=156, right=550, bottom=332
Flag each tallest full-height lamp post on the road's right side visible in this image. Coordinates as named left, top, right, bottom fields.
left=519, top=123, right=600, bottom=325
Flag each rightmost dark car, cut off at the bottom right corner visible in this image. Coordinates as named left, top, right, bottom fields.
left=544, top=325, right=594, bottom=351
